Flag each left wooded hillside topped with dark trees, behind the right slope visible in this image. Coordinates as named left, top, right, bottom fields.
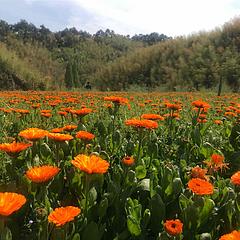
left=0, top=20, right=168, bottom=89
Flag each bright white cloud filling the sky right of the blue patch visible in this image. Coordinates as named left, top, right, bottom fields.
left=69, top=0, right=240, bottom=36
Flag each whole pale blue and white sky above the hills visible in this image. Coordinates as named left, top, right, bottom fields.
left=0, top=0, right=240, bottom=37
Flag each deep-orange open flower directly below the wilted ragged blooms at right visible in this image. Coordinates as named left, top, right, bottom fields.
left=188, top=178, right=213, bottom=195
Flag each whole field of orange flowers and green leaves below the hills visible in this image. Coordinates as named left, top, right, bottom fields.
left=0, top=91, right=240, bottom=240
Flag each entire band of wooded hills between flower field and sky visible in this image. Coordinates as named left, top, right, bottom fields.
left=0, top=18, right=240, bottom=92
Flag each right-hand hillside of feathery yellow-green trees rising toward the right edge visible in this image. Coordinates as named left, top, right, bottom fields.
left=91, top=18, right=240, bottom=92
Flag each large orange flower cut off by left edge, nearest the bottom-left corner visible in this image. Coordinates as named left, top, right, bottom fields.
left=0, top=192, right=27, bottom=216
